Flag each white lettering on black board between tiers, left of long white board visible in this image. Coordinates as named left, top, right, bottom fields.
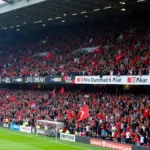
left=25, top=77, right=45, bottom=83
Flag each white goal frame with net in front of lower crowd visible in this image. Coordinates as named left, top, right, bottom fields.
left=36, top=120, right=64, bottom=142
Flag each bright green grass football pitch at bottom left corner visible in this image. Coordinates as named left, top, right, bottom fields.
left=0, top=128, right=110, bottom=150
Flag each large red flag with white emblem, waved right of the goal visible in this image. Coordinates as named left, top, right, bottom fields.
left=79, top=105, right=89, bottom=121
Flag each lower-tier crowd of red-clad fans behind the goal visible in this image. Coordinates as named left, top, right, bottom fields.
left=0, top=89, right=150, bottom=147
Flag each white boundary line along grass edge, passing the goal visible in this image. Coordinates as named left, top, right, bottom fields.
left=0, top=129, right=87, bottom=150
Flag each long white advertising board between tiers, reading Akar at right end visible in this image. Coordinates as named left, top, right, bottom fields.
left=75, top=76, right=150, bottom=85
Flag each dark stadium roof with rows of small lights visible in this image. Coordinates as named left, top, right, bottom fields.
left=0, top=0, right=150, bottom=31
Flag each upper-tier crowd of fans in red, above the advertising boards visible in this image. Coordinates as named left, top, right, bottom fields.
left=0, top=19, right=150, bottom=77
